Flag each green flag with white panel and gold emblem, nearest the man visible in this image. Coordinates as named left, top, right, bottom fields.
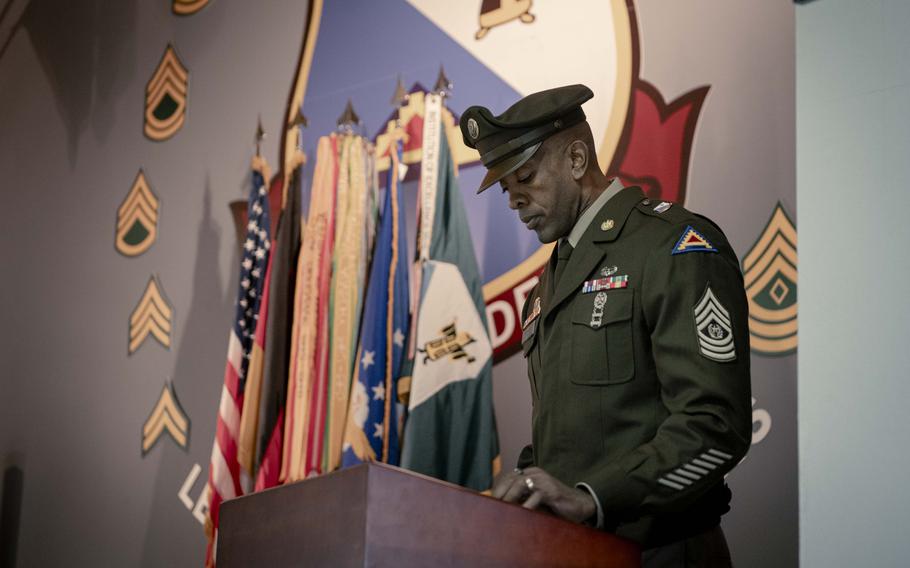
left=401, top=94, right=499, bottom=490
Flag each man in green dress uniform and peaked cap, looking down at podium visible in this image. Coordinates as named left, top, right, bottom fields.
left=460, top=85, right=752, bottom=567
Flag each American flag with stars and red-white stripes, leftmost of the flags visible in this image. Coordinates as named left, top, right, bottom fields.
left=206, top=169, right=271, bottom=566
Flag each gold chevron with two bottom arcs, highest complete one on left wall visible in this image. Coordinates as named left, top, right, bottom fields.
left=144, top=44, right=189, bottom=141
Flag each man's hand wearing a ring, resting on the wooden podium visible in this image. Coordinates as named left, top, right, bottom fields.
left=492, top=467, right=597, bottom=523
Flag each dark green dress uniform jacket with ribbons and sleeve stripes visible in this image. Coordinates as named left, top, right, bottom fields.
left=518, top=187, right=752, bottom=548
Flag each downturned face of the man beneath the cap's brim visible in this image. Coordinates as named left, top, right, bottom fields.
left=499, top=140, right=581, bottom=243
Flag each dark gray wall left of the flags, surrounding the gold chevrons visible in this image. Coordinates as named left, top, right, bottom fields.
left=0, top=0, right=306, bottom=566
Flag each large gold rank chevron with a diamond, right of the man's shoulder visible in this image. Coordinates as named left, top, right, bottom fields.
left=743, top=203, right=798, bottom=356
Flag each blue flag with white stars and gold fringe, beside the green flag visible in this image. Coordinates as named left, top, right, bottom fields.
left=342, top=144, right=409, bottom=467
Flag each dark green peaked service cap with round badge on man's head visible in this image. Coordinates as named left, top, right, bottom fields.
left=460, top=85, right=594, bottom=193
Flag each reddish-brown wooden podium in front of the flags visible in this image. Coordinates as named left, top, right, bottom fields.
left=217, top=464, right=641, bottom=568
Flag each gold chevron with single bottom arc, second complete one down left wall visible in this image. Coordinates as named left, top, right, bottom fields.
left=114, top=170, right=158, bottom=256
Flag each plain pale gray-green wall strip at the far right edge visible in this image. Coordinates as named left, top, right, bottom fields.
left=797, top=0, right=910, bottom=567
